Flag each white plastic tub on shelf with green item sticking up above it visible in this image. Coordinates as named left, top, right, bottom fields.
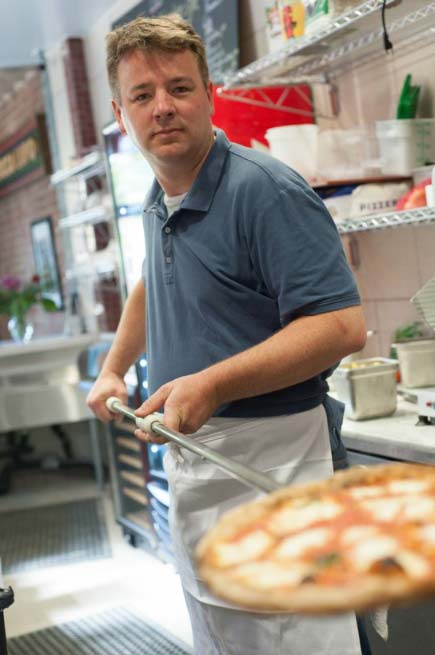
left=376, top=118, right=435, bottom=175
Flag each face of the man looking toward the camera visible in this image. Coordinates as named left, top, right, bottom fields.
left=112, top=50, right=213, bottom=169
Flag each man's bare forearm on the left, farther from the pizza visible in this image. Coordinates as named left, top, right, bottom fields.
left=101, top=281, right=145, bottom=377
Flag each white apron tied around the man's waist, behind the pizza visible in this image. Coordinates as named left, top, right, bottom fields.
left=164, top=406, right=361, bottom=655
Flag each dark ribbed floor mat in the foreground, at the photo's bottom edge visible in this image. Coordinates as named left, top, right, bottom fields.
left=8, top=607, right=192, bottom=655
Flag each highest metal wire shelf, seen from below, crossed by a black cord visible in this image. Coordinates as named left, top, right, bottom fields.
left=223, top=0, right=435, bottom=93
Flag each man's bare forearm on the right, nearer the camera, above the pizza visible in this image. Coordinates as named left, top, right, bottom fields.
left=203, top=307, right=366, bottom=403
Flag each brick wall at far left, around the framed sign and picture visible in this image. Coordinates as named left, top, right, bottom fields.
left=0, top=71, right=63, bottom=339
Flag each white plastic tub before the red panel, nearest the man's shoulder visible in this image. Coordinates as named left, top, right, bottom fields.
left=266, top=123, right=319, bottom=181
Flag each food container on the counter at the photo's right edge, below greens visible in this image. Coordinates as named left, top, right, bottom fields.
left=394, top=339, right=435, bottom=388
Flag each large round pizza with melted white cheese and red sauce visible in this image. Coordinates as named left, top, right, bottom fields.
left=196, top=464, right=435, bottom=614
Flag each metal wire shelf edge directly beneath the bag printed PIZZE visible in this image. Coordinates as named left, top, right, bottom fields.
left=337, top=207, right=435, bottom=234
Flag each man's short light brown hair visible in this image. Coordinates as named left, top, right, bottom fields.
left=106, top=14, right=209, bottom=103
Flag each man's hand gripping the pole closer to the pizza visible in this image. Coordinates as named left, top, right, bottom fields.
left=135, top=371, right=221, bottom=443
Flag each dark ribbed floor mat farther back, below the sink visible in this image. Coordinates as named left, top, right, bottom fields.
left=0, top=498, right=111, bottom=575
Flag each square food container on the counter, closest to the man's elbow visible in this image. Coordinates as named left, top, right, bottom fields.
left=332, top=357, right=398, bottom=421
